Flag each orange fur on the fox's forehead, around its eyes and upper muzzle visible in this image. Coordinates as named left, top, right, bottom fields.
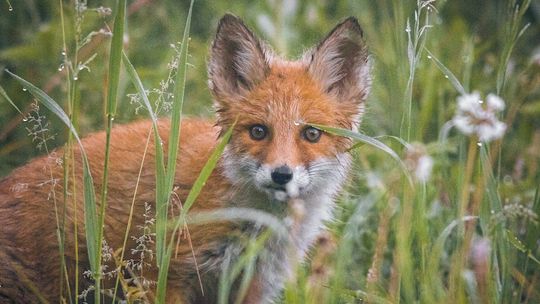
left=227, top=63, right=352, bottom=170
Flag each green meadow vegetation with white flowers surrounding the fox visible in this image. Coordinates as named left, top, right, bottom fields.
left=0, top=0, right=540, bottom=303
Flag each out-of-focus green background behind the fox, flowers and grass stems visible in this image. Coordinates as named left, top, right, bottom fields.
left=0, top=0, right=540, bottom=303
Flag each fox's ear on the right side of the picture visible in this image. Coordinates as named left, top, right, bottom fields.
left=307, top=17, right=371, bottom=103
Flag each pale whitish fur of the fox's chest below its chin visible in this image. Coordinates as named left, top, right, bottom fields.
left=197, top=195, right=333, bottom=303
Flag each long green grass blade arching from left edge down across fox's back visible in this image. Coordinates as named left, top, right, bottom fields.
left=6, top=71, right=99, bottom=273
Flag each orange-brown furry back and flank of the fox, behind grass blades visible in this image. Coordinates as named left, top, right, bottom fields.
left=0, top=119, right=227, bottom=302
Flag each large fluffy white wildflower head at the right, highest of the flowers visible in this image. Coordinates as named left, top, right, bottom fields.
left=452, top=92, right=506, bottom=142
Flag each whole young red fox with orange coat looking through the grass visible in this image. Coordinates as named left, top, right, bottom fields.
left=0, top=14, right=371, bottom=303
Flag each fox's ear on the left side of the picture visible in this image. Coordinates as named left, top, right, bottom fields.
left=208, top=14, right=269, bottom=99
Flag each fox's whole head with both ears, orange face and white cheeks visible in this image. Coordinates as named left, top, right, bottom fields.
left=208, top=15, right=370, bottom=201
